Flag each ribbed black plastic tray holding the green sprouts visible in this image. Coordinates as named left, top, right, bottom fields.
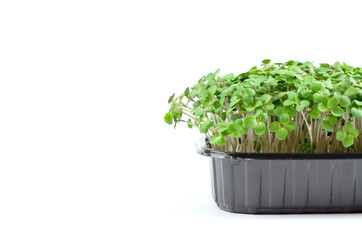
left=198, top=148, right=362, bottom=214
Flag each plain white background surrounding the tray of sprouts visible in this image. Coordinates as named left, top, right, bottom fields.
left=0, top=0, right=362, bottom=240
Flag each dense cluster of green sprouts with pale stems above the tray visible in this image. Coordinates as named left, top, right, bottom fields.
left=164, top=59, right=362, bottom=153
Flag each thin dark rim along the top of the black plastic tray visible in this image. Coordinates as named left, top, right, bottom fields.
left=197, top=147, right=362, bottom=160
